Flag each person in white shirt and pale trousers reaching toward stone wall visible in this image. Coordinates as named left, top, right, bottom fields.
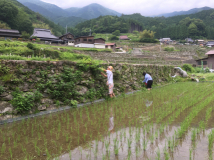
left=101, top=66, right=115, bottom=98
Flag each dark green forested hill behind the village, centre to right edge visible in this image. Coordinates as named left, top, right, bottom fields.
left=69, top=9, right=214, bottom=40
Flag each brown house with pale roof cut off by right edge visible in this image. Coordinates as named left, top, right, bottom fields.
left=196, top=50, right=214, bottom=69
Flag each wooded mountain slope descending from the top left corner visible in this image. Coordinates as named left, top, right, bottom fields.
left=0, top=0, right=65, bottom=36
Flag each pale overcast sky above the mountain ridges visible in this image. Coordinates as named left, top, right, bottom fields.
left=42, top=0, right=214, bottom=16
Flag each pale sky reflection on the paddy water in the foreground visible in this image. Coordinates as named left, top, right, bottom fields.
left=54, top=126, right=214, bottom=160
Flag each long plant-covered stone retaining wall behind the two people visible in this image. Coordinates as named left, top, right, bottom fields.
left=0, top=60, right=174, bottom=120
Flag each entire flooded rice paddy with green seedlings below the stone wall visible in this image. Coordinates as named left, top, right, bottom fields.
left=0, top=83, right=214, bottom=160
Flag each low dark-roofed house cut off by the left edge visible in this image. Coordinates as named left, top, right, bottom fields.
left=0, top=29, right=21, bottom=40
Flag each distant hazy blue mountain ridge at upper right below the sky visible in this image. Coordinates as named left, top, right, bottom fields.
left=157, top=7, right=212, bottom=17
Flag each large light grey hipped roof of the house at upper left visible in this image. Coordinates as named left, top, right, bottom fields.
left=31, top=28, right=59, bottom=39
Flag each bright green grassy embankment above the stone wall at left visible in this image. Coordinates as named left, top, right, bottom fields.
left=0, top=41, right=111, bottom=63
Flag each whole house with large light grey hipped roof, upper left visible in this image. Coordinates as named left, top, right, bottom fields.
left=30, top=28, right=62, bottom=43
